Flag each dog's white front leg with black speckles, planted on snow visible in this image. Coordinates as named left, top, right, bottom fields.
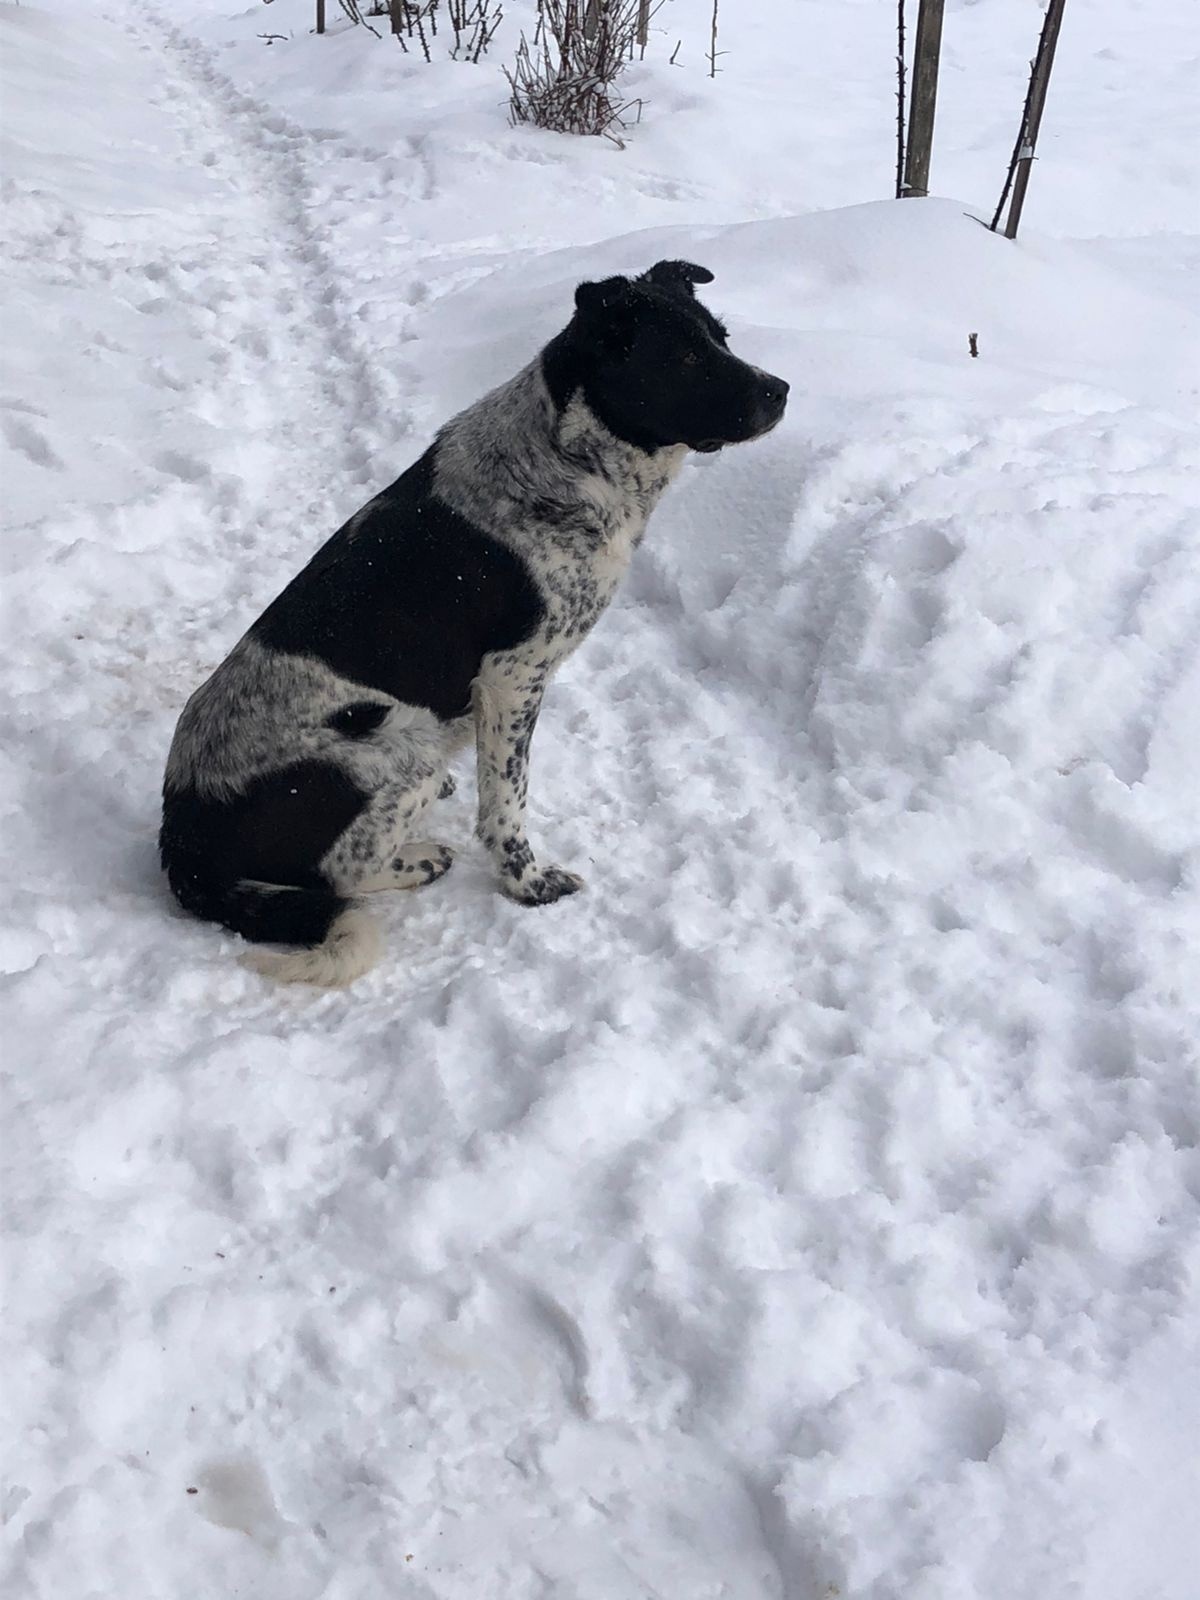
left=475, top=664, right=584, bottom=906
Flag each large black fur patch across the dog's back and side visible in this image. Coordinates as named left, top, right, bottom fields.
left=260, top=445, right=544, bottom=722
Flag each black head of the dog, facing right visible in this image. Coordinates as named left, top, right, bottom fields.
left=558, top=261, right=787, bottom=451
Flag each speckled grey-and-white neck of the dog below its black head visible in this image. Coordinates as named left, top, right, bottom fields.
left=434, top=357, right=688, bottom=547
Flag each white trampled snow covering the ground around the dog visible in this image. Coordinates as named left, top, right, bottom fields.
left=0, top=0, right=1200, bottom=1600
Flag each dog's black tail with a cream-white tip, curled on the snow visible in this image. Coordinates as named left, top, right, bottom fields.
left=168, top=856, right=382, bottom=989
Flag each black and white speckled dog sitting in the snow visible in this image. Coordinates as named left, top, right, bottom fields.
left=158, top=261, right=787, bottom=984
